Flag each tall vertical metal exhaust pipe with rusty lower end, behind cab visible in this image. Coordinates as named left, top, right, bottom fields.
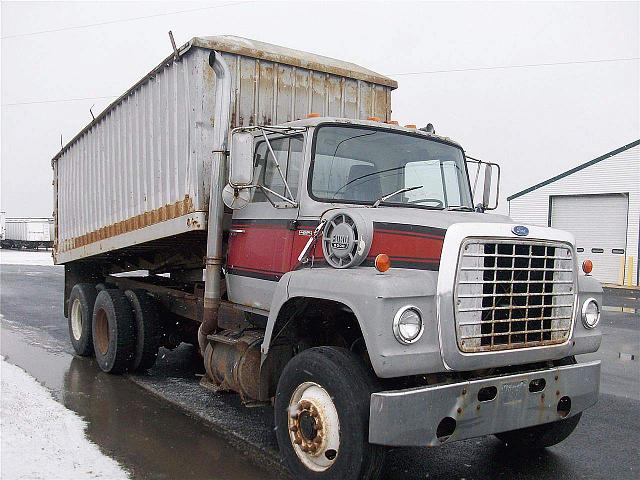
left=198, top=51, right=233, bottom=354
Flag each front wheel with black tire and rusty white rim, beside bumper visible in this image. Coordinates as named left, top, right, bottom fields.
left=275, top=347, right=384, bottom=480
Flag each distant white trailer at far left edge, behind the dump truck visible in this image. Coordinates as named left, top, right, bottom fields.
left=0, top=217, right=54, bottom=249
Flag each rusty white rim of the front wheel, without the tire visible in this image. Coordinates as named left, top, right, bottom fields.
left=287, top=382, right=340, bottom=472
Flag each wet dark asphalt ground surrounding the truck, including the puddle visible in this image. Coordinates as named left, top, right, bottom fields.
left=0, top=265, right=640, bottom=480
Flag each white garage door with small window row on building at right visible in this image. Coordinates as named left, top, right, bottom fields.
left=550, top=194, right=629, bottom=283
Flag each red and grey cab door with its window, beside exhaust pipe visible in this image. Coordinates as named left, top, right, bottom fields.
left=226, top=135, right=303, bottom=310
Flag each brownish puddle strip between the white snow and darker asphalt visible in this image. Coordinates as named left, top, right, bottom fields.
left=0, top=323, right=278, bottom=480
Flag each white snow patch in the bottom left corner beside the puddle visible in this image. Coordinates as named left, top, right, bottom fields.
left=0, top=357, right=129, bottom=480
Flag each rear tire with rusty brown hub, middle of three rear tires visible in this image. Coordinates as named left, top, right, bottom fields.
left=92, top=289, right=135, bottom=373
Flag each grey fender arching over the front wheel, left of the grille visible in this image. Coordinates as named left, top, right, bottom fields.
left=261, top=267, right=443, bottom=378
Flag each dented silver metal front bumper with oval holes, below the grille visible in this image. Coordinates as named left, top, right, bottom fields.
left=369, top=361, right=600, bottom=446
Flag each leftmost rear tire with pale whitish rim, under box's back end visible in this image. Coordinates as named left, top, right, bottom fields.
left=68, top=283, right=97, bottom=357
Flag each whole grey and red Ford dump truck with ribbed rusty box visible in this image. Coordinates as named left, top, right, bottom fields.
left=52, top=36, right=602, bottom=479
